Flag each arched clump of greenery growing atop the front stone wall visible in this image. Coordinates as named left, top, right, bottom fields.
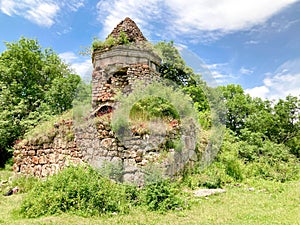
left=111, top=82, right=197, bottom=137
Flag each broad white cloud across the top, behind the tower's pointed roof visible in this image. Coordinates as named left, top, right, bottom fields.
left=97, top=0, right=297, bottom=40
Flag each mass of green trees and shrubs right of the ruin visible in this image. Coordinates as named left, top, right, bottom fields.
left=155, top=42, right=300, bottom=188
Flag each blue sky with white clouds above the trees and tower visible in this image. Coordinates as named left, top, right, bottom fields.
left=0, top=0, right=300, bottom=99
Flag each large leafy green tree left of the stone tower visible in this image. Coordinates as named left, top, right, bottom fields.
left=0, top=37, right=80, bottom=166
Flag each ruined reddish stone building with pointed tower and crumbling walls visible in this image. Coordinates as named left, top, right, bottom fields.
left=14, top=18, right=197, bottom=185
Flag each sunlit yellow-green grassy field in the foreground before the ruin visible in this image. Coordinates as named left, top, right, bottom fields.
left=0, top=175, right=300, bottom=225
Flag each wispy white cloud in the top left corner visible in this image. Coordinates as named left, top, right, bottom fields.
left=0, top=0, right=85, bottom=27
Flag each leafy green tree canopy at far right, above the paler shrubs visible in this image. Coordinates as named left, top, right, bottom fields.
left=218, top=84, right=300, bottom=157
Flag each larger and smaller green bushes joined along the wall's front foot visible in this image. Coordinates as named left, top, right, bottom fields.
left=20, top=166, right=184, bottom=218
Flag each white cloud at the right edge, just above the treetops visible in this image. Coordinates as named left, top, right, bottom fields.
left=245, top=58, right=300, bottom=99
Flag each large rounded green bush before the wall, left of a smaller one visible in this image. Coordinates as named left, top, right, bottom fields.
left=20, top=166, right=130, bottom=218
